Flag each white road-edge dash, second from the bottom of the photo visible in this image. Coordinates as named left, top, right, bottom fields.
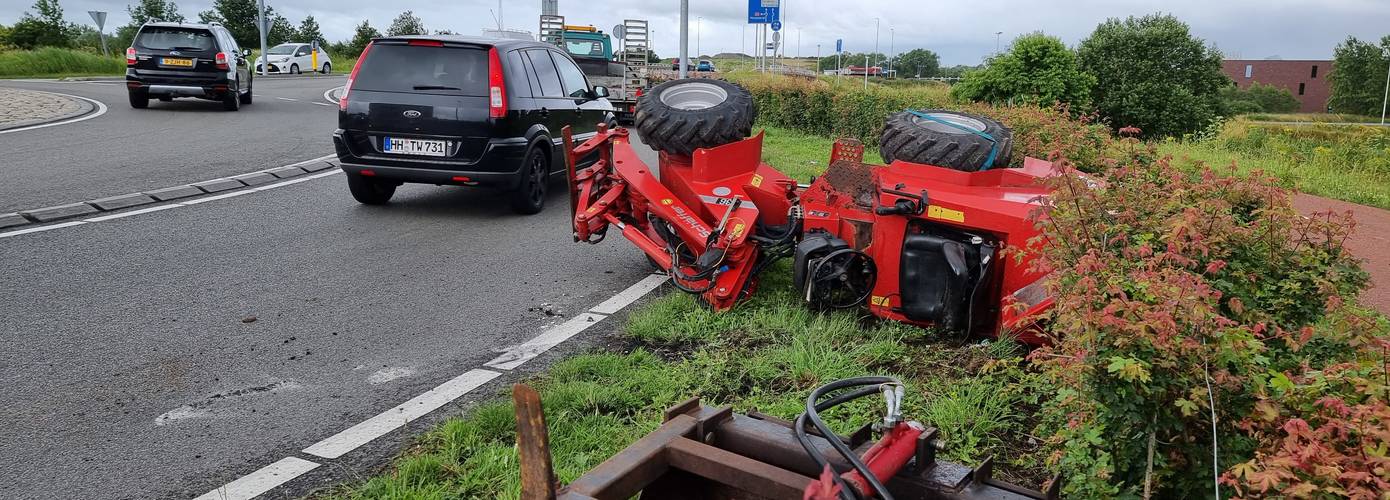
left=304, top=369, right=502, bottom=458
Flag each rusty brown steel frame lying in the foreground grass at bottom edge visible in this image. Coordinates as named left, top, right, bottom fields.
left=513, top=383, right=1061, bottom=500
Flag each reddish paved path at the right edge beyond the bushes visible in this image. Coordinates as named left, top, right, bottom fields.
left=1294, top=193, right=1390, bottom=314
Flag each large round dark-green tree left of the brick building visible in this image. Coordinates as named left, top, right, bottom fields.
left=1077, top=14, right=1230, bottom=138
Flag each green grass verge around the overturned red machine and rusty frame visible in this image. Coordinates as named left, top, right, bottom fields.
left=321, top=128, right=1045, bottom=499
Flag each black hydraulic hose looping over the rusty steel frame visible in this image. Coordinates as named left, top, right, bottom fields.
left=794, top=376, right=902, bottom=500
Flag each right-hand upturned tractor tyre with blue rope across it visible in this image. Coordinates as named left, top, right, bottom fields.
left=878, top=110, right=1013, bottom=172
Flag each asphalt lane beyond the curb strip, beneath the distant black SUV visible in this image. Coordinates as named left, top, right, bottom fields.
left=0, top=75, right=346, bottom=213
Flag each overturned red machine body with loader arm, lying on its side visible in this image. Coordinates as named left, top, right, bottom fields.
left=566, top=117, right=1052, bottom=342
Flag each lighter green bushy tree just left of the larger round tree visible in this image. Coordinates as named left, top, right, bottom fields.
left=951, top=33, right=1095, bottom=107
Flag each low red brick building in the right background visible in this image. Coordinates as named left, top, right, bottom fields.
left=1222, top=60, right=1332, bottom=113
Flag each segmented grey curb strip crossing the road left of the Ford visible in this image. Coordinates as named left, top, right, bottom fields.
left=0, top=154, right=338, bottom=229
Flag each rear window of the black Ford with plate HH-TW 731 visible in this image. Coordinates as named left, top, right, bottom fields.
left=352, top=43, right=488, bottom=96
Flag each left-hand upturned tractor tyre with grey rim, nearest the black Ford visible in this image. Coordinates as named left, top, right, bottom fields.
left=634, top=78, right=758, bottom=157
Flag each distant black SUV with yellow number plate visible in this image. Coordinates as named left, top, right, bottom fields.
left=125, top=22, right=252, bottom=111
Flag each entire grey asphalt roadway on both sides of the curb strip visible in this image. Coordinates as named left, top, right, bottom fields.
left=0, top=79, right=661, bottom=499
